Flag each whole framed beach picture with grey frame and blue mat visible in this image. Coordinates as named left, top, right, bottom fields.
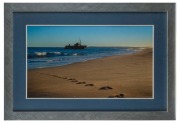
left=5, top=3, right=175, bottom=120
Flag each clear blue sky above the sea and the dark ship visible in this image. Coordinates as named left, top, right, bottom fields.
left=27, top=26, right=153, bottom=47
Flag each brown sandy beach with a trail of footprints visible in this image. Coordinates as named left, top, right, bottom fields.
left=27, top=48, right=153, bottom=98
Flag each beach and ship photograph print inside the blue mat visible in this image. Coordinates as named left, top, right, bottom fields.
left=26, top=25, right=154, bottom=99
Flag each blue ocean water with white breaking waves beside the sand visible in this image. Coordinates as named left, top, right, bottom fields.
left=27, top=47, right=142, bottom=69
